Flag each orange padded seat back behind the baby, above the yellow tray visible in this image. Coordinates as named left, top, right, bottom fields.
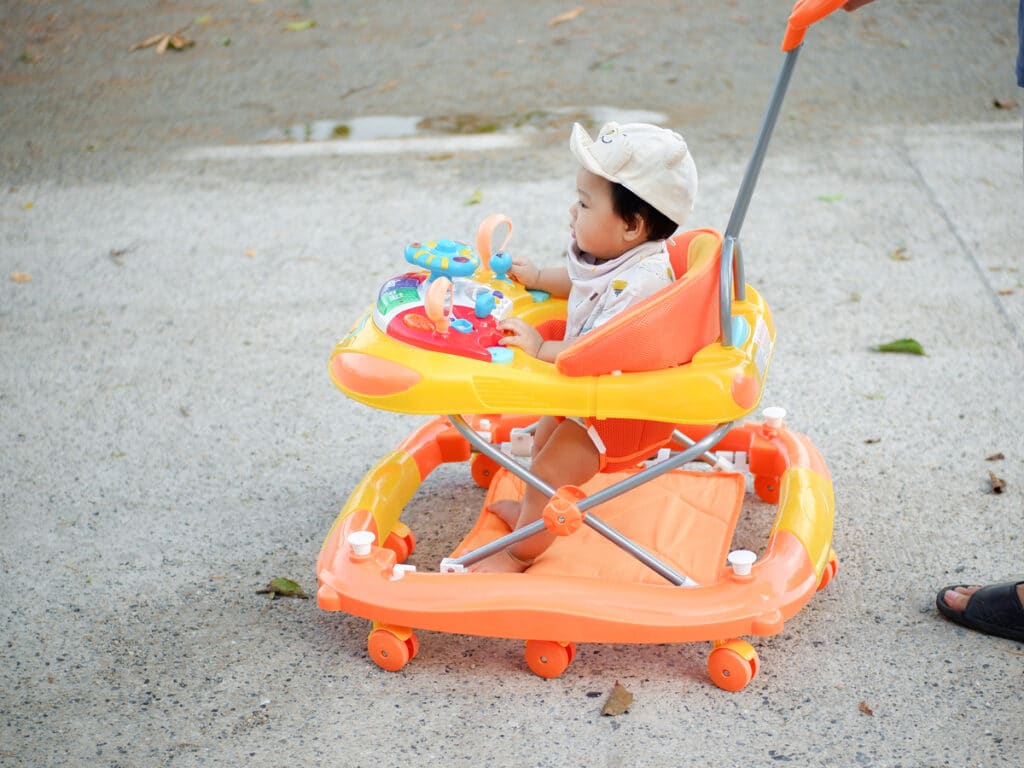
left=555, top=229, right=722, bottom=376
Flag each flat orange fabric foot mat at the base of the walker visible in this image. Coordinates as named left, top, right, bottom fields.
left=454, top=470, right=746, bottom=585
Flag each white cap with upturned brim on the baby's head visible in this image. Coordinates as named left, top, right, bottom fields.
left=569, top=123, right=697, bottom=226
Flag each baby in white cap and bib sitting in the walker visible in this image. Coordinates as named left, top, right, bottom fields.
left=470, top=123, right=697, bottom=572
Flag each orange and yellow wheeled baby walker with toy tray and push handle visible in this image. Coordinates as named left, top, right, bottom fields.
left=316, top=0, right=844, bottom=691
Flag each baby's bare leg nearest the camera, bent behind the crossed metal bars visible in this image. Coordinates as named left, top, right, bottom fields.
left=470, top=421, right=601, bottom=572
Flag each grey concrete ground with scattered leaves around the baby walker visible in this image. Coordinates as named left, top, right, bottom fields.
left=0, top=0, right=1024, bottom=768
